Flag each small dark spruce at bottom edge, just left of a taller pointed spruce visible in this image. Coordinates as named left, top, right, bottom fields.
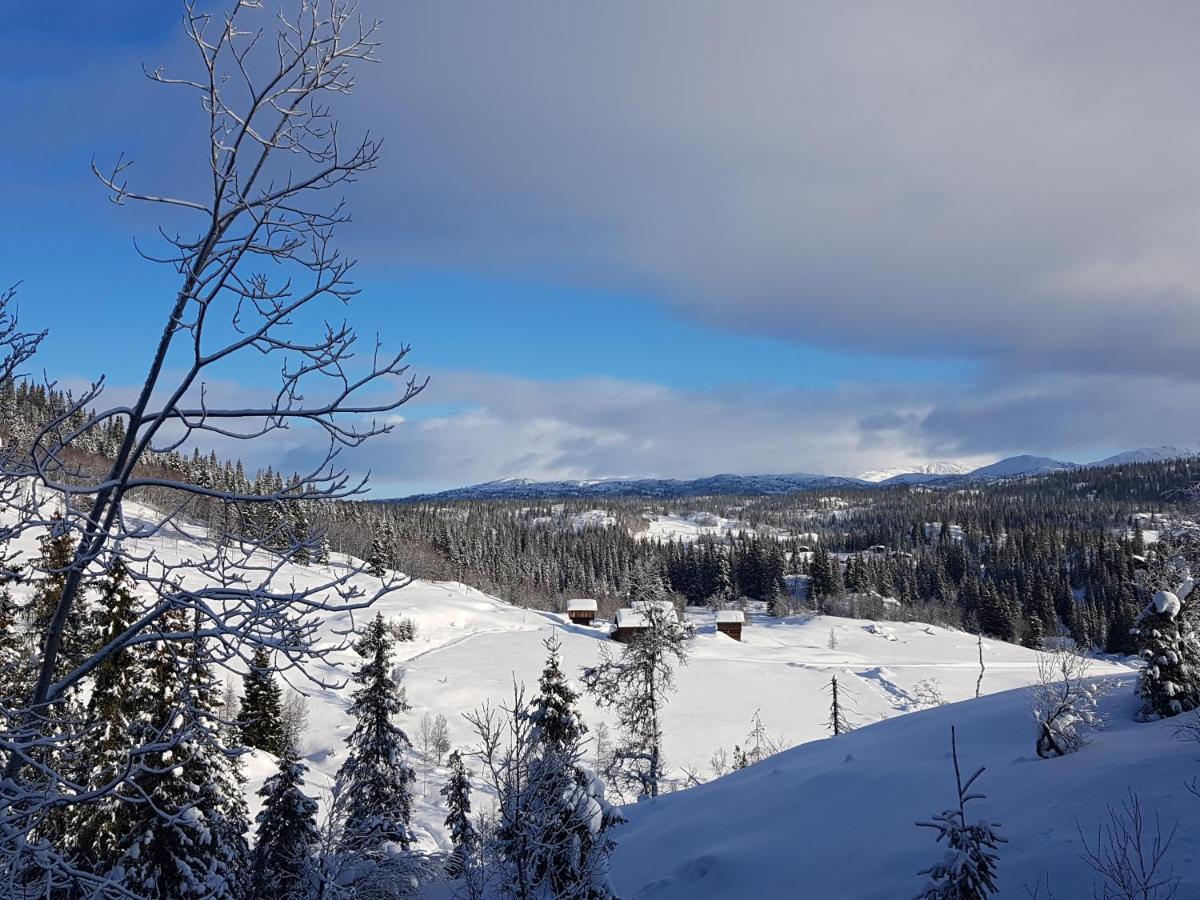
left=247, top=754, right=320, bottom=900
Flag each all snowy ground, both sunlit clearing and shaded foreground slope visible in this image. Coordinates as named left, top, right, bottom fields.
left=7, top=501, right=1171, bottom=899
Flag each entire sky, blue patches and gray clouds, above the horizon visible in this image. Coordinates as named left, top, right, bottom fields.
left=0, top=0, right=1200, bottom=492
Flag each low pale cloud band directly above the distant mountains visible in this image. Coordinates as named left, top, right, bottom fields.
left=336, top=372, right=1200, bottom=487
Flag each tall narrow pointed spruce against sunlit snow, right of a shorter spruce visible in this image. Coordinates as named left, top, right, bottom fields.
left=335, top=613, right=415, bottom=857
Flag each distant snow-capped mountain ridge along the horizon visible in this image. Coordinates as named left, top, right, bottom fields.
left=404, top=446, right=1198, bottom=500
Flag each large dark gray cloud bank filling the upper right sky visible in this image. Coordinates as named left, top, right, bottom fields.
left=326, top=2, right=1200, bottom=376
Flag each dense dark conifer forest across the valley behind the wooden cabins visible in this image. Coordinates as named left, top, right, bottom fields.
left=326, top=461, right=1200, bottom=653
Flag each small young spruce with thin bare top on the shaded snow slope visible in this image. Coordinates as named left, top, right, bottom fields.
left=916, top=726, right=1004, bottom=900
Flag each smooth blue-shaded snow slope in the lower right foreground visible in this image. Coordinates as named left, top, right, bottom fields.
left=613, top=674, right=1200, bottom=900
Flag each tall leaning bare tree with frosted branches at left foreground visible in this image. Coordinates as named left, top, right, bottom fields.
left=0, top=0, right=424, bottom=887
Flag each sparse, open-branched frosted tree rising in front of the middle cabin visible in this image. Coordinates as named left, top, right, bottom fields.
left=583, top=606, right=688, bottom=798
